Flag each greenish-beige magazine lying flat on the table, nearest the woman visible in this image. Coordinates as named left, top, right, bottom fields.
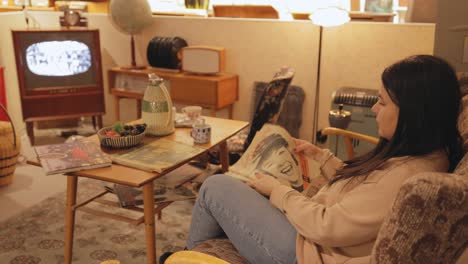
left=111, top=138, right=205, bottom=172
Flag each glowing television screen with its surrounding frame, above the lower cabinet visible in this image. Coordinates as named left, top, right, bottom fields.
left=15, top=31, right=97, bottom=90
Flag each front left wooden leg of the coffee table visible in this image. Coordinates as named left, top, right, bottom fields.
left=65, top=176, right=78, bottom=264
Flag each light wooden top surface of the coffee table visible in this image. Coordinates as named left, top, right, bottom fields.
left=64, top=116, right=248, bottom=187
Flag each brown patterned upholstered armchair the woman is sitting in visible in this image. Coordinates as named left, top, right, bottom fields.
left=166, top=129, right=468, bottom=264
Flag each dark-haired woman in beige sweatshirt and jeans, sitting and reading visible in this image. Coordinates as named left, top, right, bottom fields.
left=176, top=55, right=462, bottom=263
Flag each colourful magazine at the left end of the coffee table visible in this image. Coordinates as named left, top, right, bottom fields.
left=34, top=140, right=112, bottom=175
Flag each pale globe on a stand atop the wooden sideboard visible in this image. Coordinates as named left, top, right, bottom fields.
left=109, top=0, right=153, bottom=69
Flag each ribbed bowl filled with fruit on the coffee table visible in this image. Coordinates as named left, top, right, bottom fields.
left=97, top=122, right=146, bottom=148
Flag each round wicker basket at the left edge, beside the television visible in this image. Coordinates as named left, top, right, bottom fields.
left=0, top=104, right=20, bottom=186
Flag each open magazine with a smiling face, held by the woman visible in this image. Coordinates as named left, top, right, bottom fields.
left=226, top=124, right=320, bottom=191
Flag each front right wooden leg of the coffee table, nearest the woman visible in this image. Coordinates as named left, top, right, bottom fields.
left=143, top=181, right=156, bottom=264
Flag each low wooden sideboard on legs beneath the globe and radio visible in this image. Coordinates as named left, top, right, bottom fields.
left=108, top=67, right=239, bottom=120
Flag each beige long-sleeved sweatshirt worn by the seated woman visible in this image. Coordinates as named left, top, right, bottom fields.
left=270, top=150, right=449, bottom=264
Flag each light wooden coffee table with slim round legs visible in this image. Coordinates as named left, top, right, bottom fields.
left=52, top=117, right=248, bottom=264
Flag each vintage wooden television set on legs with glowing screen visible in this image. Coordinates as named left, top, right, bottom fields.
left=12, top=28, right=105, bottom=144
